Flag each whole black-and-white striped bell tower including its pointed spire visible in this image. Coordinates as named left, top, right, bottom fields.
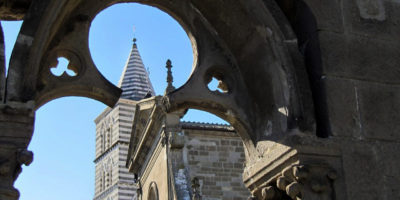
left=93, top=38, right=155, bottom=200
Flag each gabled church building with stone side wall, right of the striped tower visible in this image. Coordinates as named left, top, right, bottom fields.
left=127, top=96, right=249, bottom=200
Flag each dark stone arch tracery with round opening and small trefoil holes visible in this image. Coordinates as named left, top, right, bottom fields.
left=6, top=0, right=314, bottom=198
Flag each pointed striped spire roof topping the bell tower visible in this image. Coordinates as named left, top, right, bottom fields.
left=118, top=39, right=155, bottom=101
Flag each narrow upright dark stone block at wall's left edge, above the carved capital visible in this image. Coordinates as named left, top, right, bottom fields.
left=326, top=77, right=361, bottom=138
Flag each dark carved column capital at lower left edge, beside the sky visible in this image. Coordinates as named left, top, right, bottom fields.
left=0, top=103, right=35, bottom=200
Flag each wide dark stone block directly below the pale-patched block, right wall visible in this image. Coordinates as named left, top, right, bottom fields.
left=319, top=31, right=400, bottom=84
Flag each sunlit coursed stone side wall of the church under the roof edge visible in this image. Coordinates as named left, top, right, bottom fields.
left=183, top=126, right=250, bottom=200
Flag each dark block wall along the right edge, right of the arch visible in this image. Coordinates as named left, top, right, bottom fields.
left=306, top=0, right=400, bottom=199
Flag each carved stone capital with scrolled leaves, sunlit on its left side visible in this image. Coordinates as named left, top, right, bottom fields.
left=244, top=135, right=345, bottom=200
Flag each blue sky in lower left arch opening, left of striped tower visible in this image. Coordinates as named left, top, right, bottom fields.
left=15, top=97, right=104, bottom=200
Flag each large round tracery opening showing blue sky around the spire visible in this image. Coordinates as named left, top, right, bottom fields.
left=89, top=3, right=196, bottom=94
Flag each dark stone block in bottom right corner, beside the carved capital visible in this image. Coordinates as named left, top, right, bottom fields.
left=343, top=141, right=400, bottom=199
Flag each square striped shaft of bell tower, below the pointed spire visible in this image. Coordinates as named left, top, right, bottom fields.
left=93, top=99, right=137, bottom=200
